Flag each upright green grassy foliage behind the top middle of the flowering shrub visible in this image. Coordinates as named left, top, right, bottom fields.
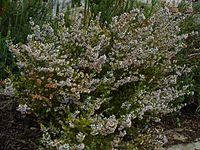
left=72, top=0, right=158, bottom=25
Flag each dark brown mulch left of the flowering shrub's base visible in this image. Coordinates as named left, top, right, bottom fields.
left=0, top=95, right=41, bottom=150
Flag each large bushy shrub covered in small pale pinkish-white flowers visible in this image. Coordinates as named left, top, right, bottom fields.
left=10, top=7, right=190, bottom=150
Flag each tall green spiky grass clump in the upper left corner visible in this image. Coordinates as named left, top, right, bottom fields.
left=0, top=0, right=52, bottom=43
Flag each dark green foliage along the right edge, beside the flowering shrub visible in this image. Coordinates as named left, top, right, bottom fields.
left=178, top=1, right=200, bottom=110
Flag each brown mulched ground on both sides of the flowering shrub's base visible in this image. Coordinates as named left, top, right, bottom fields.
left=0, top=95, right=200, bottom=150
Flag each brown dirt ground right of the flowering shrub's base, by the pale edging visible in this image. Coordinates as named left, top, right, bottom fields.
left=159, top=99, right=200, bottom=147
